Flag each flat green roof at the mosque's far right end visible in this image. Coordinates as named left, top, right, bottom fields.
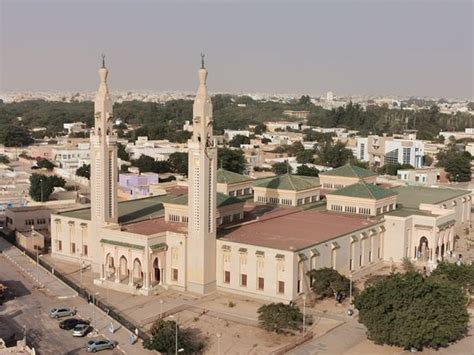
left=392, top=186, right=470, bottom=208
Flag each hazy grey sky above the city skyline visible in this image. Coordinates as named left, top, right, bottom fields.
left=0, top=0, right=474, bottom=98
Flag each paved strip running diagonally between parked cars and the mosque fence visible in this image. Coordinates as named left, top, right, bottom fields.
left=0, top=238, right=156, bottom=354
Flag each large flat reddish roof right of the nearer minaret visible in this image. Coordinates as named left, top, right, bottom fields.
left=219, top=210, right=381, bottom=251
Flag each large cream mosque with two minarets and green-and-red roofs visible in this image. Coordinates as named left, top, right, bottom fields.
left=51, top=62, right=472, bottom=302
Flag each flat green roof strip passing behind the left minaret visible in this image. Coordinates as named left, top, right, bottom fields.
left=58, top=196, right=170, bottom=224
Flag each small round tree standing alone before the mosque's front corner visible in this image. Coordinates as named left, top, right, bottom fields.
left=257, top=303, right=303, bottom=333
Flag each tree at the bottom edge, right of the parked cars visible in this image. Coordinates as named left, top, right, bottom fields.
left=143, top=319, right=204, bottom=354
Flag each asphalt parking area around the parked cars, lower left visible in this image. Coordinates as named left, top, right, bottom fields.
left=0, top=254, right=122, bottom=355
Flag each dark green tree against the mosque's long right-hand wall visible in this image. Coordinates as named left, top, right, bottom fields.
left=308, top=267, right=350, bottom=298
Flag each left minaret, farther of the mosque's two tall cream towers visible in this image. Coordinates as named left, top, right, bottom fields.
left=90, top=55, right=118, bottom=227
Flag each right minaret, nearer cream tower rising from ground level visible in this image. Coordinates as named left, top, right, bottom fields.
left=186, top=55, right=217, bottom=294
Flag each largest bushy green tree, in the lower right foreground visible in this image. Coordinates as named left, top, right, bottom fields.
left=355, top=272, right=469, bottom=350
